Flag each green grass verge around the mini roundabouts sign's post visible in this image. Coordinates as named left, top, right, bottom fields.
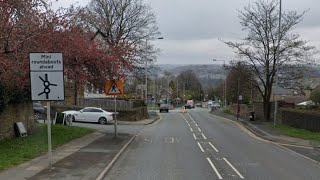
left=0, top=124, right=95, bottom=171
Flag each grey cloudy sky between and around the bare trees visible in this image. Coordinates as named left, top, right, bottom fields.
left=52, top=0, right=320, bottom=64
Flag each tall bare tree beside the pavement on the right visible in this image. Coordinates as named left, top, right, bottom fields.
left=225, top=0, right=315, bottom=120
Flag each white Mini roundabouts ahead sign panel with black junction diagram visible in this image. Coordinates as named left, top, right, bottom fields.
left=30, top=53, right=64, bottom=101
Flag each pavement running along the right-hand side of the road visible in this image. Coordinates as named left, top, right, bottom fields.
left=211, top=110, right=320, bottom=148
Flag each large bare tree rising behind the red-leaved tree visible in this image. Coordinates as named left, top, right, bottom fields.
left=79, top=0, right=159, bottom=69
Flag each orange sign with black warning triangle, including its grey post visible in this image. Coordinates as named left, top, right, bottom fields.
left=104, top=80, right=124, bottom=138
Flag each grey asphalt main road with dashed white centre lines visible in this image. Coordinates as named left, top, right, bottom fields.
left=105, top=109, right=320, bottom=180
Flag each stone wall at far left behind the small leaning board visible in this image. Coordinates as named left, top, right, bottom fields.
left=0, top=102, right=34, bottom=140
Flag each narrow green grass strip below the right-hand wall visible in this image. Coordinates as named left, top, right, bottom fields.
left=269, top=124, right=320, bottom=141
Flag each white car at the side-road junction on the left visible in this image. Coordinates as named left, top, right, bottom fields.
left=62, top=107, right=113, bottom=124
